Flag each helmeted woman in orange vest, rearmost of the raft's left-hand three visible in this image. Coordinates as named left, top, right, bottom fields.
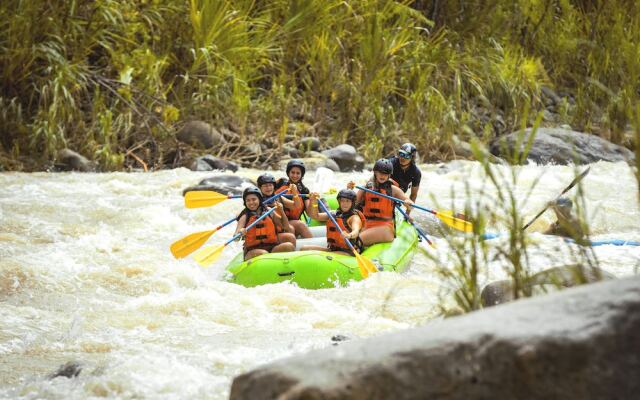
left=276, top=160, right=313, bottom=238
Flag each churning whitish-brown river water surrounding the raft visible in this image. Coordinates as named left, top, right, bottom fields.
left=0, top=162, right=640, bottom=399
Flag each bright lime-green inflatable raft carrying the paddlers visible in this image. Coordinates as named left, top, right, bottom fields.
left=227, top=196, right=418, bottom=289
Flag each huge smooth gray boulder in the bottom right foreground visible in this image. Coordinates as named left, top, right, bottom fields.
left=231, top=276, right=640, bottom=400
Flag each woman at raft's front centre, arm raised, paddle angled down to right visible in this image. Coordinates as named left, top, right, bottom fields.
left=301, top=189, right=365, bottom=256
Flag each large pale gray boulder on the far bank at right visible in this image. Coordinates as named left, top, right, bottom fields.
left=491, top=128, right=635, bottom=165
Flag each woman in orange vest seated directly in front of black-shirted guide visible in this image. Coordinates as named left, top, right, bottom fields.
left=347, top=158, right=413, bottom=246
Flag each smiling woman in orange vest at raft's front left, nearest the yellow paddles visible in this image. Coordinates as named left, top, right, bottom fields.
left=235, top=186, right=295, bottom=261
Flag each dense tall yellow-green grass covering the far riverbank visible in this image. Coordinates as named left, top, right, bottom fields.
left=0, top=0, right=640, bottom=170
